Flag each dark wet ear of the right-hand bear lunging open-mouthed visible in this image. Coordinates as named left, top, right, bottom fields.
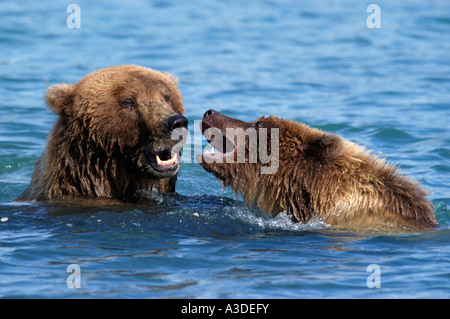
left=305, top=133, right=343, bottom=160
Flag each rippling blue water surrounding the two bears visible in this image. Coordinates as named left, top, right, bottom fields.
left=0, top=0, right=450, bottom=298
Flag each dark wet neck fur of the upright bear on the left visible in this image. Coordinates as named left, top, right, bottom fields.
left=46, top=117, right=159, bottom=200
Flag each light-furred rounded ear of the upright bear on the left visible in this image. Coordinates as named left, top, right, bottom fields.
left=45, top=83, right=76, bottom=114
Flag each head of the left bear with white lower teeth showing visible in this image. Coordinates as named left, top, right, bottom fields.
left=46, top=65, right=187, bottom=178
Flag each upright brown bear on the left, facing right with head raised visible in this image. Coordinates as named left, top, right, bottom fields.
left=15, top=65, right=188, bottom=202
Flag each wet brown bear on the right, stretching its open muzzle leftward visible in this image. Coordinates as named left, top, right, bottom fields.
left=197, top=110, right=437, bottom=231
